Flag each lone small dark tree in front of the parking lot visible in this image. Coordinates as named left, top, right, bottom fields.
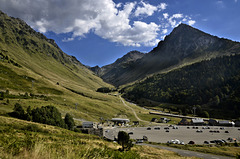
left=118, top=131, right=133, bottom=151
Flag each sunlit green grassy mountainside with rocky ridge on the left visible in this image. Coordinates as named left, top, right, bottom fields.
left=0, top=12, right=132, bottom=121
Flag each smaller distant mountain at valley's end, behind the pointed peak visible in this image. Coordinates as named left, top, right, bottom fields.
left=91, top=51, right=144, bottom=84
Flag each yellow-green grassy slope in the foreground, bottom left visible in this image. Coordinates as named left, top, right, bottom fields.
left=0, top=116, right=199, bottom=159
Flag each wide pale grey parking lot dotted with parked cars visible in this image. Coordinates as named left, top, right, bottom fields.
left=104, top=126, right=240, bottom=144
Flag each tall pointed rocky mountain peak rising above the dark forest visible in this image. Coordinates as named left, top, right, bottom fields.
left=97, top=24, right=240, bottom=86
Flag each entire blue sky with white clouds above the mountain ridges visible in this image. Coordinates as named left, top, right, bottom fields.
left=0, top=0, right=240, bottom=67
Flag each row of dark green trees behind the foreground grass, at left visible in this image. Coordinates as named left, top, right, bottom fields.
left=9, top=103, right=75, bottom=130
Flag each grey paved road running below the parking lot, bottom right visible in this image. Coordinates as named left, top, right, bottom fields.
left=139, top=143, right=232, bottom=159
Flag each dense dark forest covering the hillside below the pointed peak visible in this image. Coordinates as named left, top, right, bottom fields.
left=123, top=55, right=240, bottom=118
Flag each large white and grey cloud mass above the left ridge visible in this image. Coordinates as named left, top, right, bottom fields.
left=0, top=0, right=195, bottom=47
